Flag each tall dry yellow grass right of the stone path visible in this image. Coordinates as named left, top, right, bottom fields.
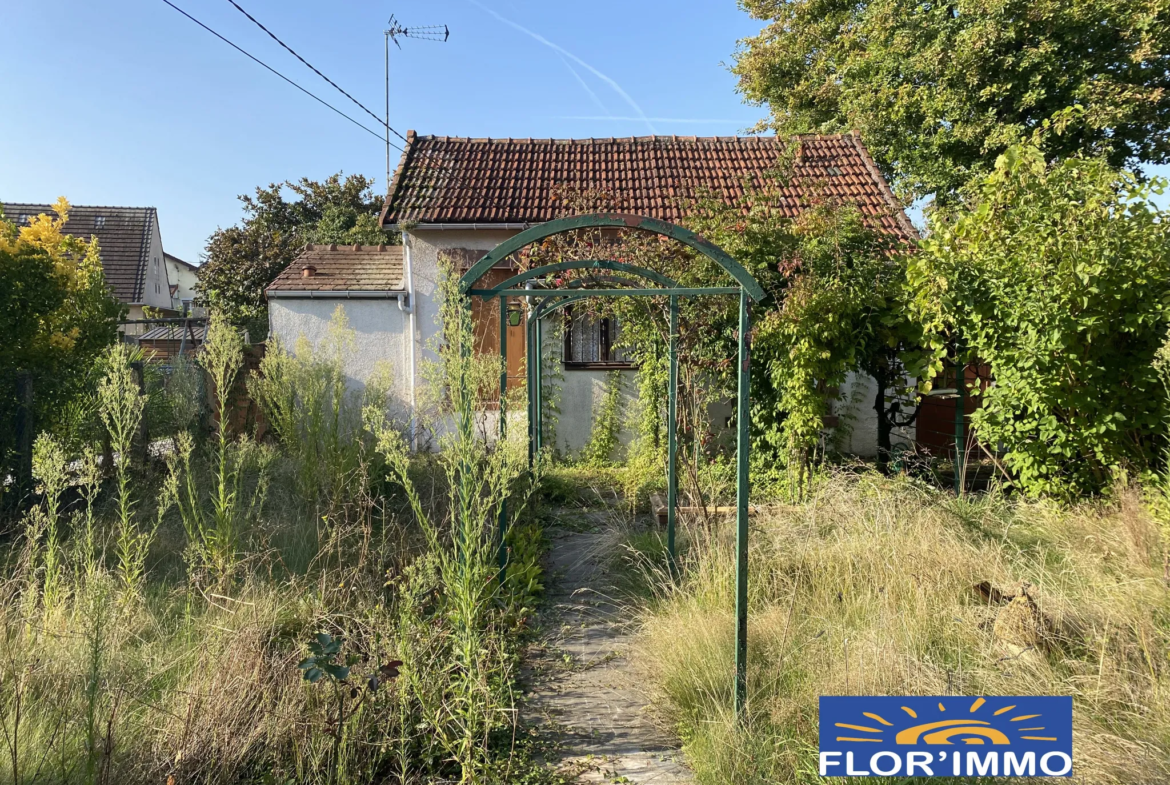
left=640, top=474, right=1170, bottom=785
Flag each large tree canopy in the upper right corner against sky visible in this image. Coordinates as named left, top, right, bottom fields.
left=734, top=0, right=1170, bottom=200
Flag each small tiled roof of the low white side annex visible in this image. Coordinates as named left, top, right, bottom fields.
left=268, top=245, right=405, bottom=297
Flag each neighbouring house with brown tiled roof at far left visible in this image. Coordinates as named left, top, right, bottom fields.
left=0, top=202, right=177, bottom=319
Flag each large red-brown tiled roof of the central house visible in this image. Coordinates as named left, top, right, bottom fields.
left=381, top=131, right=917, bottom=237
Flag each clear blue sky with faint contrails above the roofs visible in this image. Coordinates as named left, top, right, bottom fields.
left=0, top=0, right=764, bottom=261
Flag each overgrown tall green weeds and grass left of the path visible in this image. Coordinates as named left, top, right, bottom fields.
left=0, top=266, right=541, bottom=785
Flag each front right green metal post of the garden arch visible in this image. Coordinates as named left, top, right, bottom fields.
left=735, top=290, right=751, bottom=718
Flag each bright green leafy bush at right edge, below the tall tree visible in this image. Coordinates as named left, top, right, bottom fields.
left=909, top=145, right=1170, bottom=497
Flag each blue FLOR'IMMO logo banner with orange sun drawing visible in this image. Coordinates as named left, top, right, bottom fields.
left=820, top=695, right=1073, bottom=777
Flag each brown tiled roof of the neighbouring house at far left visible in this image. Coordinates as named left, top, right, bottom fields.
left=0, top=202, right=158, bottom=303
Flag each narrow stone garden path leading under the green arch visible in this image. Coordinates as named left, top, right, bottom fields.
left=523, top=511, right=694, bottom=785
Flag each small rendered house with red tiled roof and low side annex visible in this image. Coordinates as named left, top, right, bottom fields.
left=269, top=131, right=916, bottom=454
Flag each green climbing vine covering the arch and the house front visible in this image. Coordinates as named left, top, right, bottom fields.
left=523, top=177, right=921, bottom=495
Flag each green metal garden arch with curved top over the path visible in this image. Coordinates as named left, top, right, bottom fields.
left=460, top=213, right=765, bottom=714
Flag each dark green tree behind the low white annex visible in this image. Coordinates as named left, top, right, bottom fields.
left=197, top=173, right=397, bottom=336
